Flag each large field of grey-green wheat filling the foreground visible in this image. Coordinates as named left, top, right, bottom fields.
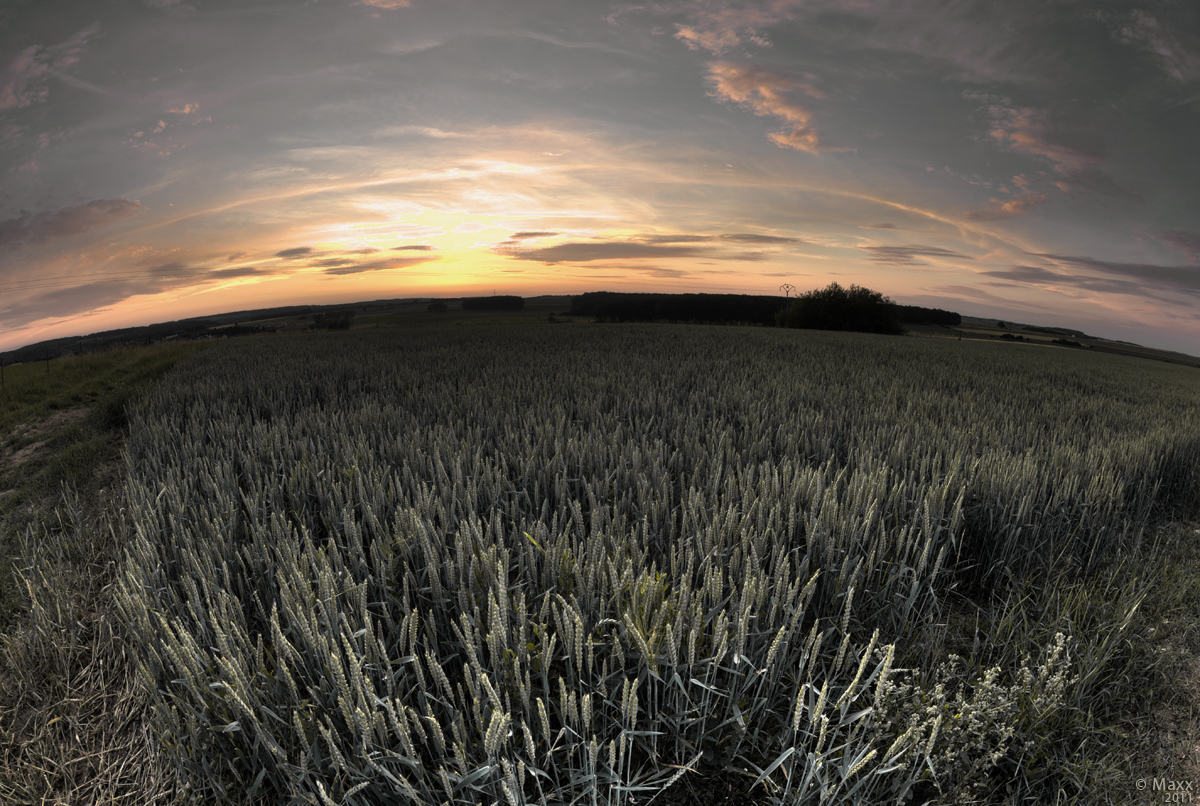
left=105, top=323, right=1200, bottom=805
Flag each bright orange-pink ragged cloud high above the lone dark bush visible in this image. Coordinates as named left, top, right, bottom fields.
left=708, top=61, right=824, bottom=154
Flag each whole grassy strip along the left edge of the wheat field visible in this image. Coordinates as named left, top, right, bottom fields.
left=0, top=344, right=211, bottom=804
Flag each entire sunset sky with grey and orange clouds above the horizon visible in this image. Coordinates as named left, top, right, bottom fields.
left=0, top=0, right=1200, bottom=355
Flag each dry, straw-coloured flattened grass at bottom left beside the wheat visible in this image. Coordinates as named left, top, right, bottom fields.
left=0, top=474, right=172, bottom=804
